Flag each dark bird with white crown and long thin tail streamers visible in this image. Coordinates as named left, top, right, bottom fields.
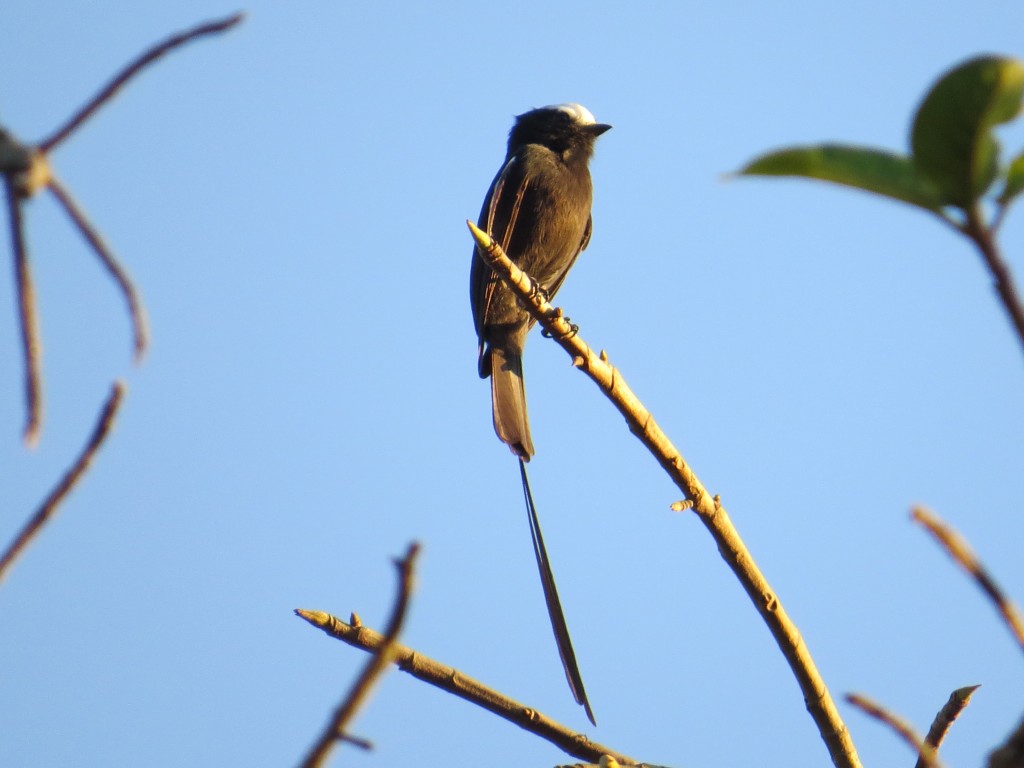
left=470, top=103, right=611, bottom=725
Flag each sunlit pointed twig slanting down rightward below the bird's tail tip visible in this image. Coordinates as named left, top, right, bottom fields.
left=295, top=608, right=638, bottom=765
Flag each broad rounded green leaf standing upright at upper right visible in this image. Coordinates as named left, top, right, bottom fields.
left=910, top=56, right=1024, bottom=210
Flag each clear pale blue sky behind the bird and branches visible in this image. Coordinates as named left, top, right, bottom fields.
left=0, top=0, right=1024, bottom=768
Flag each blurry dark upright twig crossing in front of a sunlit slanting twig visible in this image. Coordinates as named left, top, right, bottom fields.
left=302, top=542, right=420, bottom=768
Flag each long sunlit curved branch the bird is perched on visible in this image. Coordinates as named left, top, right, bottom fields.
left=466, top=221, right=860, bottom=768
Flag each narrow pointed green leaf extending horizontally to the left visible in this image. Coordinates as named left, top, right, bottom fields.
left=739, top=144, right=942, bottom=212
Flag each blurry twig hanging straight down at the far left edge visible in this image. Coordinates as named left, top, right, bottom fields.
left=4, top=175, right=43, bottom=445
